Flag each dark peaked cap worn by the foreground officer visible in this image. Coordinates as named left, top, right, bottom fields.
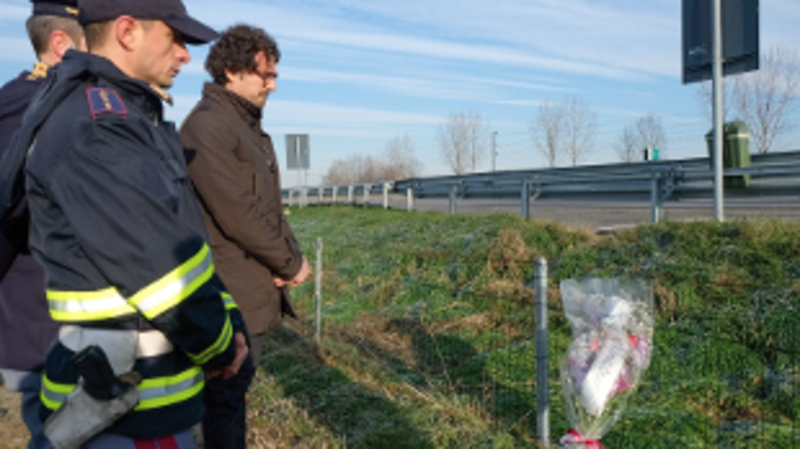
left=78, top=0, right=219, bottom=44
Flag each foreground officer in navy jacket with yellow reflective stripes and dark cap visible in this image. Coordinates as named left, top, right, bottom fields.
left=0, top=0, right=247, bottom=449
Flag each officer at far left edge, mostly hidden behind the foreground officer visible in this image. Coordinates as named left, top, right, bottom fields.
left=0, top=0, right=85, bottom=447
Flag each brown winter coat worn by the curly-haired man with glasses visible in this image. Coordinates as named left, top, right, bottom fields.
left=180, top=83, right=302, bottom=335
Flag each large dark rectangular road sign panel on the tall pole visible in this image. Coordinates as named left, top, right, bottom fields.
left=683, top=0, right=759, bottom=84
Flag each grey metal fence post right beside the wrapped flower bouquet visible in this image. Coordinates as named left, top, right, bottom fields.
left=534, top=257, right=550, bottom=447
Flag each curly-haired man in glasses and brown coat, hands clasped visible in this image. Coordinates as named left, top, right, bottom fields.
left=181, top=25, right=310, bottom=449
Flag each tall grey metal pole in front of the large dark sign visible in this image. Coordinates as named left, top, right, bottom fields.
left=712, top=0, right=725, bottom=222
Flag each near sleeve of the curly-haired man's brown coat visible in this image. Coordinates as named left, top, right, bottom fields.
left=180, top=112, right=302, bottom=280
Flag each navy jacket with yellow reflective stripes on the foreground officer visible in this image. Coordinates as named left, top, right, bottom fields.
left=0, top=52, right=245, bottom=438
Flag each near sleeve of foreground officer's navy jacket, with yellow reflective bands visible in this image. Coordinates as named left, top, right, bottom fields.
left=45, top=121, right=236, bottom=367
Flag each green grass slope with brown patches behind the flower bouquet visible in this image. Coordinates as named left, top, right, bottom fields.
left=251, top=207, right=800, bottom=448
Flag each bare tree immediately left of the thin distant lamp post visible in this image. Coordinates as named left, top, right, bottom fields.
left=438, top=112, right=486, bottom=175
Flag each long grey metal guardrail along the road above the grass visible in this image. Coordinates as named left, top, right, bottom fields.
left=283, top=151, right=800, bottom=222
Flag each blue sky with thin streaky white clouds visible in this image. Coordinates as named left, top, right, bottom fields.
left=0, top=0, right=800, bottom=185
